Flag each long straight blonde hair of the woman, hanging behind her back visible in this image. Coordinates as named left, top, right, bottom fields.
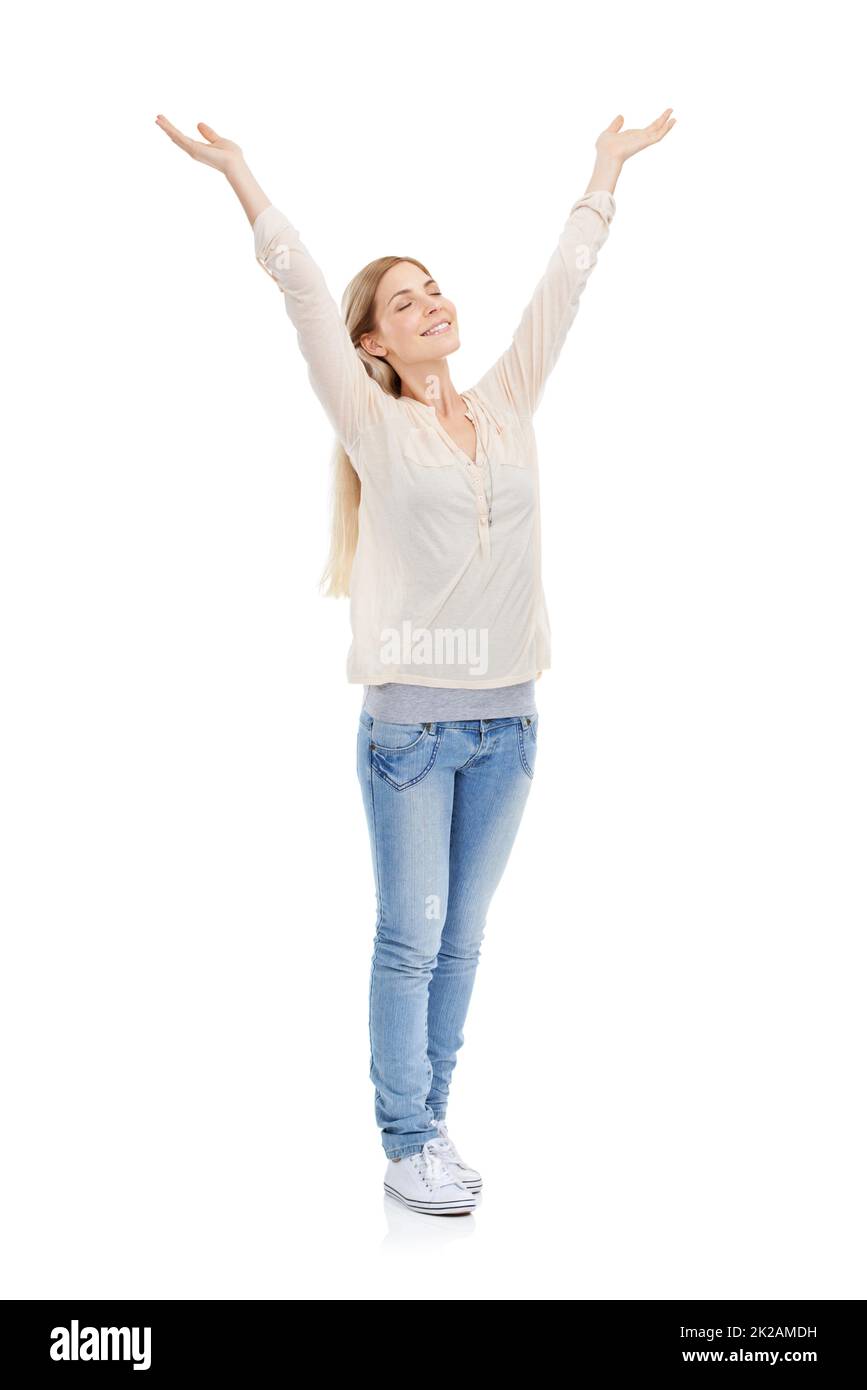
left=320, top=256, right=431, bottom=599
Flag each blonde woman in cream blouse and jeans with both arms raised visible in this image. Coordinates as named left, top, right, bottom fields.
left=157, top=107, right=675, bottom=1215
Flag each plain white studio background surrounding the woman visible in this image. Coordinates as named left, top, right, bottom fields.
left=0, top=3, right=867, bottom=1301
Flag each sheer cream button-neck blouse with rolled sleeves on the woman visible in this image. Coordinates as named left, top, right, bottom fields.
left=253, top=190, right=616, bottom=689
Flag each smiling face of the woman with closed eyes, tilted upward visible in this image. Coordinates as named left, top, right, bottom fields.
left=361, top=261, right=460, bottom=364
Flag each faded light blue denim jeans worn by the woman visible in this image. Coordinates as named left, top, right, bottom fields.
left=357, top=710, right=538, bottom=1158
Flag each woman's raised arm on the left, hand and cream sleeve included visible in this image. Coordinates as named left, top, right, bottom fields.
left=157, top=115, right=383, bottom=453
